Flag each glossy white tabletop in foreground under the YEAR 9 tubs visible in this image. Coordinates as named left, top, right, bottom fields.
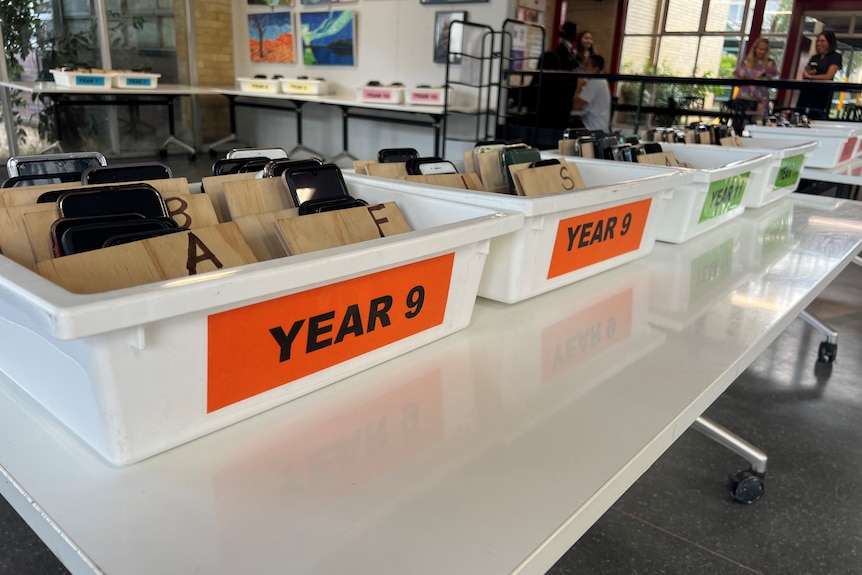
left=0, top=194, right=862, bottom=575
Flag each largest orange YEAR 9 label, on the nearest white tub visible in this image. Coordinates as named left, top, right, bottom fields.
left=207, top=254, right=455, bottom=413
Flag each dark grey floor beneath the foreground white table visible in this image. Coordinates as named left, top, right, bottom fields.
left=0, top=156, right=862, bottom=575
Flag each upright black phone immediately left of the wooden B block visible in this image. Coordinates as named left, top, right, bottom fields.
left=57, top=183, right=168, bottom=218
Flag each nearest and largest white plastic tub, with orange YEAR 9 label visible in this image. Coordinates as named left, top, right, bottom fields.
left=0, top=181, right=524, bottom=465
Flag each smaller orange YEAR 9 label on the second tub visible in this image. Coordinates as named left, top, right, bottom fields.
left=548, top=199, right=652, bottom=279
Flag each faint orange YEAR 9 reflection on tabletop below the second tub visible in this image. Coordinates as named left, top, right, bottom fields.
left=542, top=289, right=634, bottom=382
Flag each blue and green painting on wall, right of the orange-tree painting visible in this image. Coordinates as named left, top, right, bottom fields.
left=299, top=10, right=356, bottom=66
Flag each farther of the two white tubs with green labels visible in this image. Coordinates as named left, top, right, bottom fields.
left=739, top=138, right=820, bottom=208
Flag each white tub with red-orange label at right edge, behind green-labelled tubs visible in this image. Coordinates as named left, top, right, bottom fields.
left=745, top=122, right=862, bottom=168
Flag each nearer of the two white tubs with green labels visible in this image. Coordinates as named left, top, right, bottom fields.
left=656, top=143, right=773, bottom=243
